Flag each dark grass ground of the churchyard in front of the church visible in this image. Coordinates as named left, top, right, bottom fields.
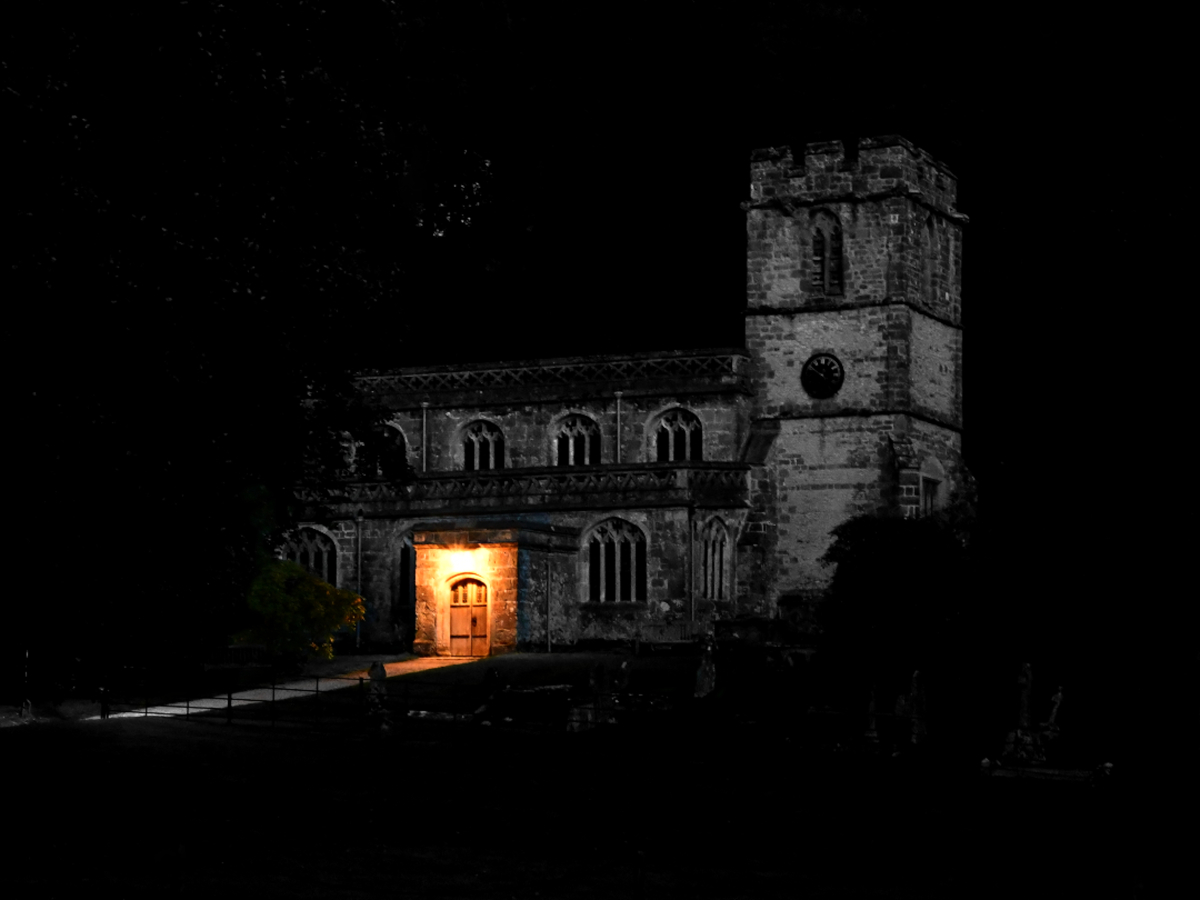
left=0, top=654, right=1159, bottom=900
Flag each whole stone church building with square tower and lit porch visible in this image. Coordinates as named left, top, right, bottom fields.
left=286, top=137, right=966, bottom=655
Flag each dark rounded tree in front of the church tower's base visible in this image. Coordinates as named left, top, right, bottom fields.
left=820, top=502, right=1013, bottom=752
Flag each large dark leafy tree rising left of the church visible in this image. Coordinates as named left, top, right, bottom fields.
left=4, top=2, right=491, bottom=649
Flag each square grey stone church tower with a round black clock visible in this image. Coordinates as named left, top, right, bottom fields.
left=738, top=137, right=966, bottom=612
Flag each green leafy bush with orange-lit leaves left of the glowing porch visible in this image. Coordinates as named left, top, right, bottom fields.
left=240, top=559, right=365, bottom=659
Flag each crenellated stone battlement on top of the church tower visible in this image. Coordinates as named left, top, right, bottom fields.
left=749, top=134, right=966, bottom=221
